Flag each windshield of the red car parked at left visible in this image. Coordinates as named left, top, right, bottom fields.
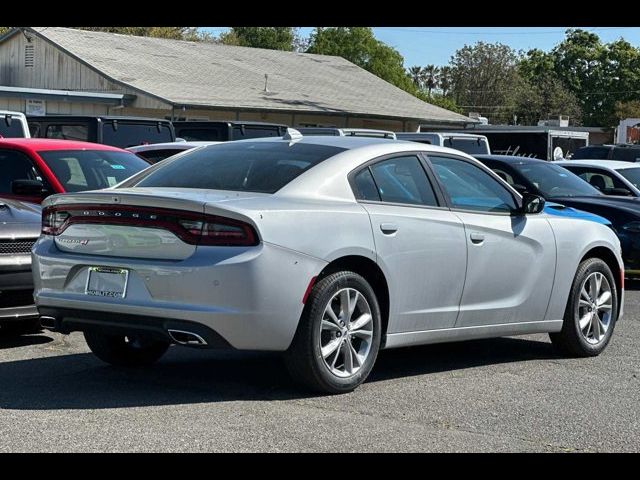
left=38, top=150, right=149, bottom=192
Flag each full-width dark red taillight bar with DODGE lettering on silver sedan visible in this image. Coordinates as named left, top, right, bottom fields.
left=42, top=205, right=258, bottom=246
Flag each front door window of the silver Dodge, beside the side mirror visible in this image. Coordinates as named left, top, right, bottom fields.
left=429, top=156, right=517, bottom=213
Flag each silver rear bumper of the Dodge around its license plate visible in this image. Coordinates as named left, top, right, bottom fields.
left=33, top=237, right=326, bottom=351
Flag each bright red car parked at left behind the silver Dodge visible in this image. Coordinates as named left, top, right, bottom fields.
left=0, top=138, right=149, bottom=203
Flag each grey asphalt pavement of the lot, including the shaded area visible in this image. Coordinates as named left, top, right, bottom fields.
left=0, top=282, right=640, bottom=452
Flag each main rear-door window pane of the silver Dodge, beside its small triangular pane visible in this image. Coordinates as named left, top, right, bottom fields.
left=370, top=156, right=438, bottom=206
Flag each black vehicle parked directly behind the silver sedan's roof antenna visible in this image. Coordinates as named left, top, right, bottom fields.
left=172, top=120, right=287, bottom=143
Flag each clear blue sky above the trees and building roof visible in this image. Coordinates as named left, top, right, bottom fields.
left=202, top=27, right=640, bottom=67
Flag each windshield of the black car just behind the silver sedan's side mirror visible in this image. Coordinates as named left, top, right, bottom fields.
left=513, top=162, right=602, bottom=197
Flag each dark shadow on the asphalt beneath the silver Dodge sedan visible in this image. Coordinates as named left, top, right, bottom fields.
left=0, top=338, right=557, bottom=410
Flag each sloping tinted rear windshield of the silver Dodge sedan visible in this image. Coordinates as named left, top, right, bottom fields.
left=136, top=142, right=344, bottom=193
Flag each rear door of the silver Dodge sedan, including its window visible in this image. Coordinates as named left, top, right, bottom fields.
left=350, top=154, right=467, bottom=333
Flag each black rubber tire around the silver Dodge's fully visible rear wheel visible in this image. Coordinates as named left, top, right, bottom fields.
left=285, top=271, right=382, bottom=393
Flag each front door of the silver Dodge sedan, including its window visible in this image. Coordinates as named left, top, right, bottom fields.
left=429, top=155, right=556, bottom=327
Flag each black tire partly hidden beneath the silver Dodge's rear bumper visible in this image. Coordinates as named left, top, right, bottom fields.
left=84, top=331, right=169, bottom=367
